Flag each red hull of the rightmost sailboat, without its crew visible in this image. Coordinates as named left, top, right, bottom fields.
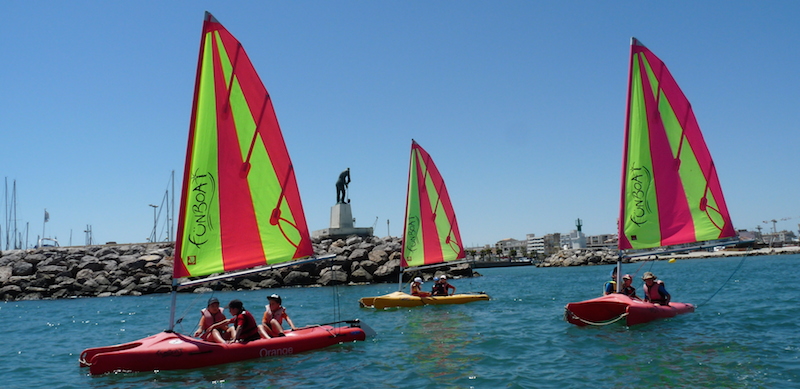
left=564, top=293, right=695, bottom=327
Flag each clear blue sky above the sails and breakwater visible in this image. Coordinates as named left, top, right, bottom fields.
left=0, top=1, right=800, bottom=248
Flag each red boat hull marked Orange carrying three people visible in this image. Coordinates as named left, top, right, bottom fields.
left=80, top=326, right=366, bottom=374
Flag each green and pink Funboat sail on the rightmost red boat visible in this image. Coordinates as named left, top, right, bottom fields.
left=619, top=38, right=736, bottom=250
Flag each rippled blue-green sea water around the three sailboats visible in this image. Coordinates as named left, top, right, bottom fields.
left=0, top=255, right=800, bottom=388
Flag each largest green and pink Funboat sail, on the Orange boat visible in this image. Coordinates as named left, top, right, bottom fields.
left=173, top=13, right=313, bottom=278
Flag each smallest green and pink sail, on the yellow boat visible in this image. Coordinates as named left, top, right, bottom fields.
left=401, top=140, right=465, bottom=268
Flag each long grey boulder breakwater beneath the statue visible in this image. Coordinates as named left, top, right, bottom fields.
left=0, top=236, right=477, bottom=301
